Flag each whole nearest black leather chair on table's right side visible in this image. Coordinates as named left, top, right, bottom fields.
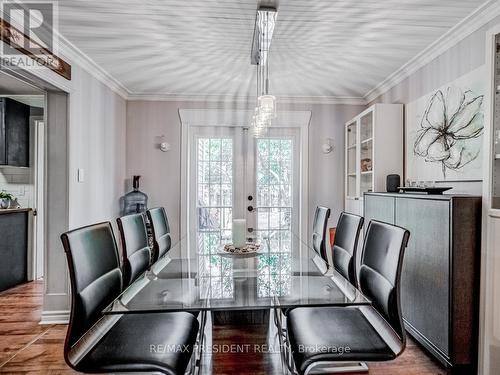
left=287, top=221, right=410, bottom=374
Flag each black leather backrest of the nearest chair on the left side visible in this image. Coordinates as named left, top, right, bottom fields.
left=61, top=222, right=122, bottom=353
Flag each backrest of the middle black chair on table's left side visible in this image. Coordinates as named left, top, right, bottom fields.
left=117, top=214, right=151, bottom=286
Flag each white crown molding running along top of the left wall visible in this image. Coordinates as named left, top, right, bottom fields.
left=56, top=31, right=129, bottom=100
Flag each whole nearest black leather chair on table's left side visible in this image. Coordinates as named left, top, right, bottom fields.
left=61, top=222, right=199, bottom=375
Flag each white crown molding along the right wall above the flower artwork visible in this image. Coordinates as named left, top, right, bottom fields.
left=364, top=0, right=500, bottom=103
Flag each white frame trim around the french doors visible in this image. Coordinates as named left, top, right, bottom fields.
left=179, top=109, right=311, bottom=258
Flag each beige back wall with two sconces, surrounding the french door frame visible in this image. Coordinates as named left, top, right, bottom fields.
left=127, top=101, right=364, bottom=239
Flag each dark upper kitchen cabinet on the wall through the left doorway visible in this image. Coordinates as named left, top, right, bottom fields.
left=0, top=98, right=30, bottom=167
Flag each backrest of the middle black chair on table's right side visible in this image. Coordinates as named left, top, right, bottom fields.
left=333, top=212, right=365, bottom=286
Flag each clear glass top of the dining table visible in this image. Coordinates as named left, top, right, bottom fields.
left=103, top=235, right=370, bottom=314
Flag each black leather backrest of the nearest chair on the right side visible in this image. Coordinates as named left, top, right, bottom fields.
left=359, top=220, right=410, bottom=341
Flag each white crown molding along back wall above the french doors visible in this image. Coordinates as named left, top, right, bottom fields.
left=127, top=93, right=367, bottom=105
